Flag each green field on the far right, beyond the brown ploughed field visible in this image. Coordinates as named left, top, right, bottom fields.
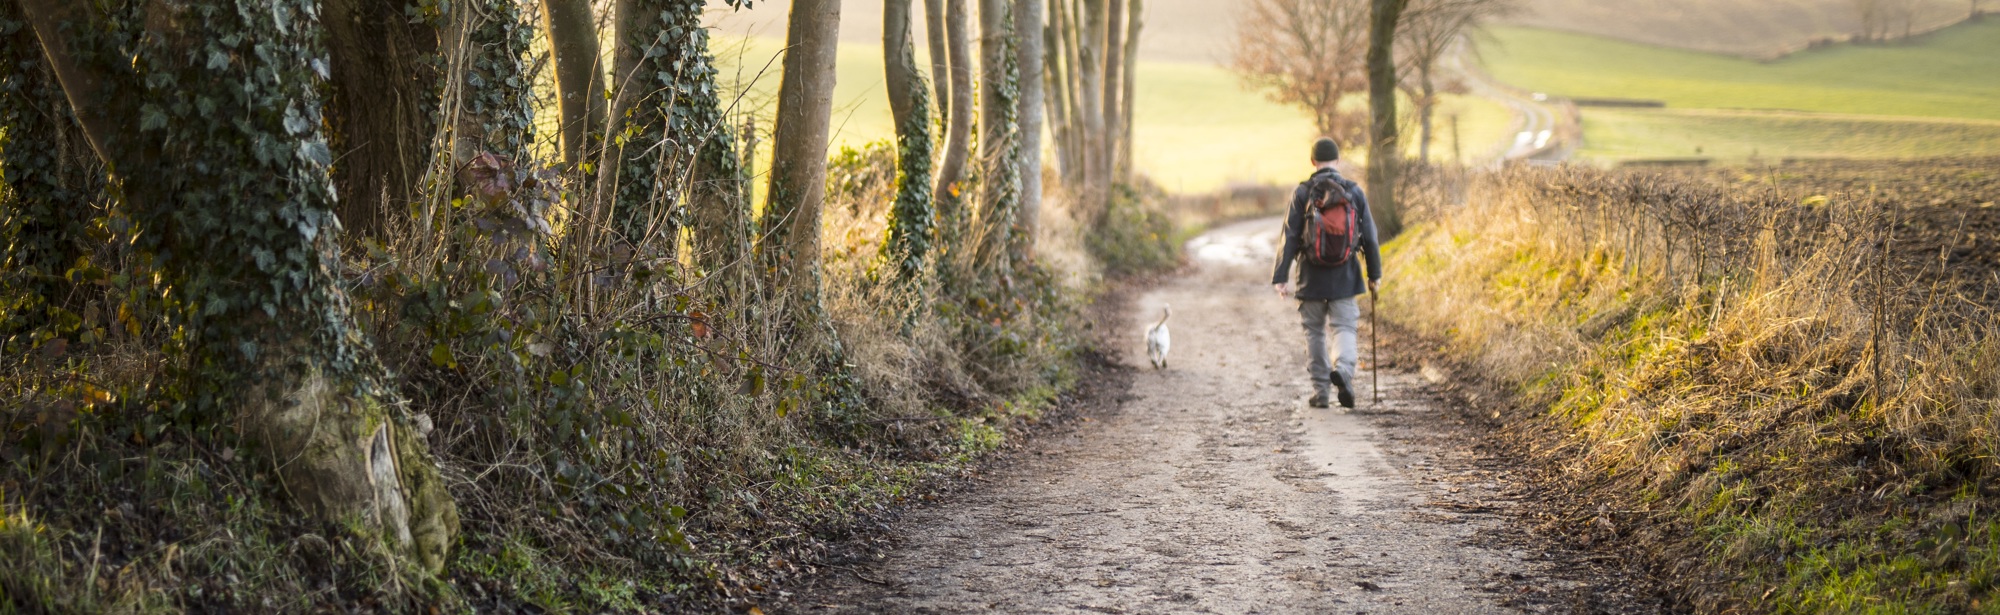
left=1486, top=20, right=2000, bottom=160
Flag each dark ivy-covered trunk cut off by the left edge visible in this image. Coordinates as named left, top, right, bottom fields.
left=0, top=2, right=104, bottom=327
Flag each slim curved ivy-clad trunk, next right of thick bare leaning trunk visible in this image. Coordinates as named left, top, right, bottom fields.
left=882, top=0, right=936, bottom=281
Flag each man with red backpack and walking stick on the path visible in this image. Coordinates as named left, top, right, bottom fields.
left=1270, top=138, right=1382, bottom=407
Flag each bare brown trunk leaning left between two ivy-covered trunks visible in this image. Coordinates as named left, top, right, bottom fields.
left=542, top=0, right=604, bottom=172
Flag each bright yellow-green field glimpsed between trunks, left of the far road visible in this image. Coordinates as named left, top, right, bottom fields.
left=712, top=36, right=1514, bottom=194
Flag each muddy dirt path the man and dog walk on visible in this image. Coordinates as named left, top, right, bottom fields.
left=772, top=220, right=1650, bottom=615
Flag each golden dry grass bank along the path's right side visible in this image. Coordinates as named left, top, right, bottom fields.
left=1384, top=162, right=2000, bottom=613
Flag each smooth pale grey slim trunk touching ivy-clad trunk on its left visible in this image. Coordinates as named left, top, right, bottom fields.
left=1012, top=0, right=1048, bottom=264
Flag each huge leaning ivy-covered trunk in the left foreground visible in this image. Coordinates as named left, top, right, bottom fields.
left=20, top=0, right=458, bottom=571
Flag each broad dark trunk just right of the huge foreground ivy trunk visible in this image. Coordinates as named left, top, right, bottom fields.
left=322, top=0, right=442, bottom=238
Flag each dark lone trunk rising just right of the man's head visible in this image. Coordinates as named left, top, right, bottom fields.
left=1368, top=0, right=1410, bottom=238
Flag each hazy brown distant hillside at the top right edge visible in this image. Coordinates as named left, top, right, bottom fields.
left=1512, top=0, right=1968, bottom=58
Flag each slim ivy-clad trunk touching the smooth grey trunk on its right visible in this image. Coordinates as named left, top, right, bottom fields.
left=978, top=0, right=1020, bottom=280
